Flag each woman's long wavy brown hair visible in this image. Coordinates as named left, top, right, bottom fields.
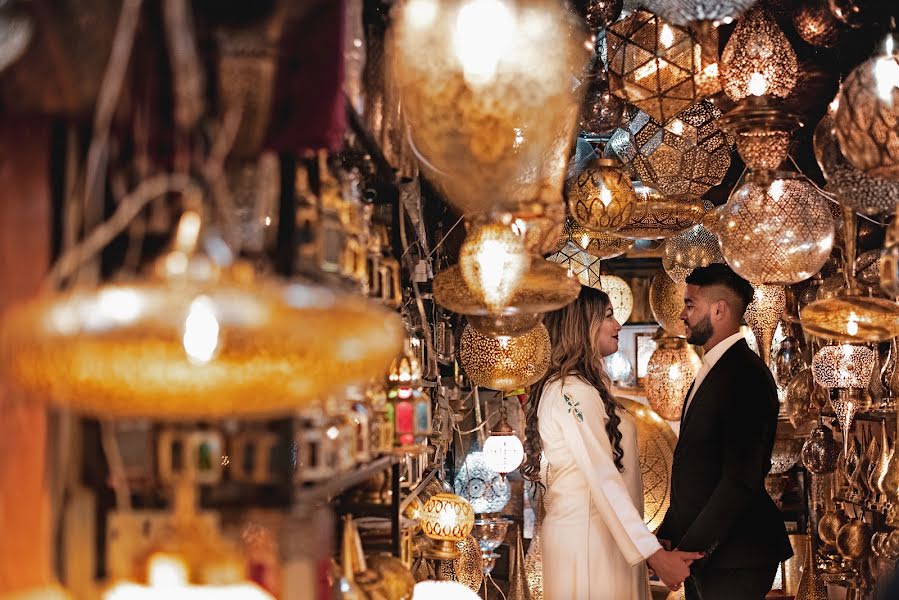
left=520, top=286, right=624, bottom=481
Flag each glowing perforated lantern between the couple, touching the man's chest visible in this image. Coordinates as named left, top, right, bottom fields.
left=645, top=335, right=702, bottom=421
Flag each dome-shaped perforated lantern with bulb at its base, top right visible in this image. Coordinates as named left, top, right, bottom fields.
left=721, top=6, right=799, bottom=100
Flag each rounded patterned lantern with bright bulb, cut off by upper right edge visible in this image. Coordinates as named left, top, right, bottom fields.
left=833, top=34, right=899, bottom=181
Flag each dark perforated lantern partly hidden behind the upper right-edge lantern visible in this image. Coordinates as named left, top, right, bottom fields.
left=814, top=108, right=899, bottom=215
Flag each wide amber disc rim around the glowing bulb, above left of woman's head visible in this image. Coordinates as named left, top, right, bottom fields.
left=434, top=258, right=581, bottom=324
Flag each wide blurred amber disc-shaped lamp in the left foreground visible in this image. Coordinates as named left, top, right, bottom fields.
left=0, top=211, right=403, bottom=419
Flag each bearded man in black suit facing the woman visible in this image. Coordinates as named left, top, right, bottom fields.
left=658, top=264, right=793, bottom=600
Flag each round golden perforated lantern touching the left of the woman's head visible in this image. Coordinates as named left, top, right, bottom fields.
left=459, top=323, right=551, bottom=392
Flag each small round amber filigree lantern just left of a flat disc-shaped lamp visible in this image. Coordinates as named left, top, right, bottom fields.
left=568, top=158, right=637, bottom=232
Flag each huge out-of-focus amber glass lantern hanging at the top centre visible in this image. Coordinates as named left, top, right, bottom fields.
left=388, top=0, right=588, bottom=212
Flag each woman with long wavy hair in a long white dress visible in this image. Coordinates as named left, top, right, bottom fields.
left=521, top=286, right=702, bottom=600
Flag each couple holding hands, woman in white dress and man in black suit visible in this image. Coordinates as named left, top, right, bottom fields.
left=521, top=264, right=792, bottom=600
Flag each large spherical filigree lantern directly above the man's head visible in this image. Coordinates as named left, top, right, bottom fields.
left=717, top=172, right=834, bottom=285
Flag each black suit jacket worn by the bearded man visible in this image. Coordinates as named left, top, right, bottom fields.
left=658, top=340, right=793, bottom=570
